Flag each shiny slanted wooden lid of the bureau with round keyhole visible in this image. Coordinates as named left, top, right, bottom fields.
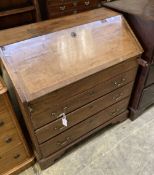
left=3, top=15, right=142, bottom=101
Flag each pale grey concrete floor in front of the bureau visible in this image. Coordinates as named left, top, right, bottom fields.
left=20, top=107, right=154, bottom=175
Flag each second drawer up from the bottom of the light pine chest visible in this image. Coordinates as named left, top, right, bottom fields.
left=0, top=129, right=21, bottom=153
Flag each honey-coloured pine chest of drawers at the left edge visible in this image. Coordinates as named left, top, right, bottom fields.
left=0, top=78, right=34, bottom=175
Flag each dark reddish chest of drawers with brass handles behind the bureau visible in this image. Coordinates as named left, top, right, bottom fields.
left=39, top=0, right=115, bottom=19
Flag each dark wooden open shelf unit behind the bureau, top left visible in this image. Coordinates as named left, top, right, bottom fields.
left=0, top=0, right=41, bottom=30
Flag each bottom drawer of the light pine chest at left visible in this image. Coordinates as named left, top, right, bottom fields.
left=0, top=144, right=27, bottom=174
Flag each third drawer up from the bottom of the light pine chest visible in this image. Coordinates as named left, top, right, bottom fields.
left=0, top=109, right=15, bottom=135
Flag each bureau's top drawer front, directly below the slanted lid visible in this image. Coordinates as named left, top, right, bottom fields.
left=30, top=60, right=137, bottom=129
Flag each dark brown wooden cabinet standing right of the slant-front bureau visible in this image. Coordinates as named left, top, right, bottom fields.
left=106, top=0, right=154, bottom=119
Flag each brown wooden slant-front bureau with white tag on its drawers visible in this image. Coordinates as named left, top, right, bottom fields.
left=1, top=9, right=142, bottom=169
